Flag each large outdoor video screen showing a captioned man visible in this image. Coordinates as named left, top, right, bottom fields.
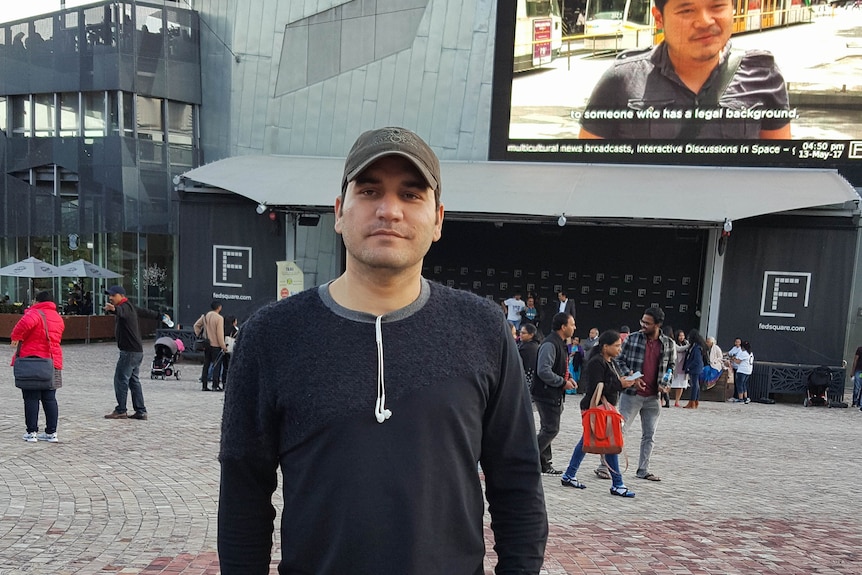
left=490, top=0, right=862, bottom=185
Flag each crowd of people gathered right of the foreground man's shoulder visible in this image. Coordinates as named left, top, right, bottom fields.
left=503, top=294, right=764, bottom=497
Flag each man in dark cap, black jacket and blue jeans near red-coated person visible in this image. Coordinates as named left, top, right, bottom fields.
left=103, top=285, right=162, bottom=421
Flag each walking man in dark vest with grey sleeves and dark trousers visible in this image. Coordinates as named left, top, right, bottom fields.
left=531, top=313, right=575, bottom=475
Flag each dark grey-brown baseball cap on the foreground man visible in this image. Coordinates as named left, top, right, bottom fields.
left=341, top=127, right=440, bottom=199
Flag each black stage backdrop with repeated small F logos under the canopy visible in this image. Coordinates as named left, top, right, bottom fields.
left=423, top=222, right=707, bottom=336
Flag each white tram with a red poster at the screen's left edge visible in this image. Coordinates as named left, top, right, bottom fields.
left=514, top=0, right=563, bottom=72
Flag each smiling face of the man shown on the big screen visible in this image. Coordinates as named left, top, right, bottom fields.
left=652, top=0, right=733, bottom=66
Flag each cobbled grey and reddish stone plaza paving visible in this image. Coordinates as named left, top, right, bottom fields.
left=0, top=341, right=862, bottom=575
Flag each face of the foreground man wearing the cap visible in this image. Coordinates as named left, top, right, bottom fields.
left=335, top=156, right=443, bottom=273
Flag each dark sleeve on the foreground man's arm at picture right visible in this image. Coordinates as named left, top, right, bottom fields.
left=481, top=322, right=548, bottom=574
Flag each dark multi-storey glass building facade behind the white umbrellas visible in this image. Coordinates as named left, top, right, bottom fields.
left=0, top=0, right=201, bottom=313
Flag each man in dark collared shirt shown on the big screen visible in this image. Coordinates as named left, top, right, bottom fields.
left=580, top=0, right=792, bottom=140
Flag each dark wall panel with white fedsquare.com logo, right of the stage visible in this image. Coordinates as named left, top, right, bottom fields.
left=719, top=224, right=856, bottom=366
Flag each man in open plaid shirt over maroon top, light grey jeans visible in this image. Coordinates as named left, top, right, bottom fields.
left=596, top=307, right=676, bottom=481
